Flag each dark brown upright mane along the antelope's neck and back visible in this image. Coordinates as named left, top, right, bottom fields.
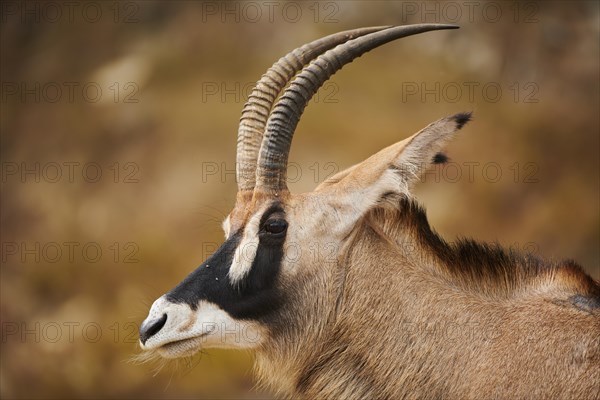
left=369, top=198, right=600, bottom=304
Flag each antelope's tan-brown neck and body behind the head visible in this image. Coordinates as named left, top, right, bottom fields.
left=258, top=201, right=600, bottom=399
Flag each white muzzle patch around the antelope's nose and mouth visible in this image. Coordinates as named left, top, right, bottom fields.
left=142, top=296, right=266, bottom=358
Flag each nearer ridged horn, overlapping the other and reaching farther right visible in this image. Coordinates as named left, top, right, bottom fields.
left=256, top=24, right=458, bottom=193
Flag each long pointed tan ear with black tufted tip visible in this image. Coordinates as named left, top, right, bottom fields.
left=315, top=113, right=471, bottom=214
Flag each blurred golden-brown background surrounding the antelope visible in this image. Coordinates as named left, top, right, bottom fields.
left=0, top=1, right=600, bottom=399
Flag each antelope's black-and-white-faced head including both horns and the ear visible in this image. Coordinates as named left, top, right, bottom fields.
left=140, top=24, right=469, bottom=358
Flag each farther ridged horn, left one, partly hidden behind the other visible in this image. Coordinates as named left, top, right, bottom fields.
left=236, top=26, right=390, bottom=191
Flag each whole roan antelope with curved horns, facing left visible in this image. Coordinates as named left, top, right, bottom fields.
left=140, top=24, right=600, bottom=399
